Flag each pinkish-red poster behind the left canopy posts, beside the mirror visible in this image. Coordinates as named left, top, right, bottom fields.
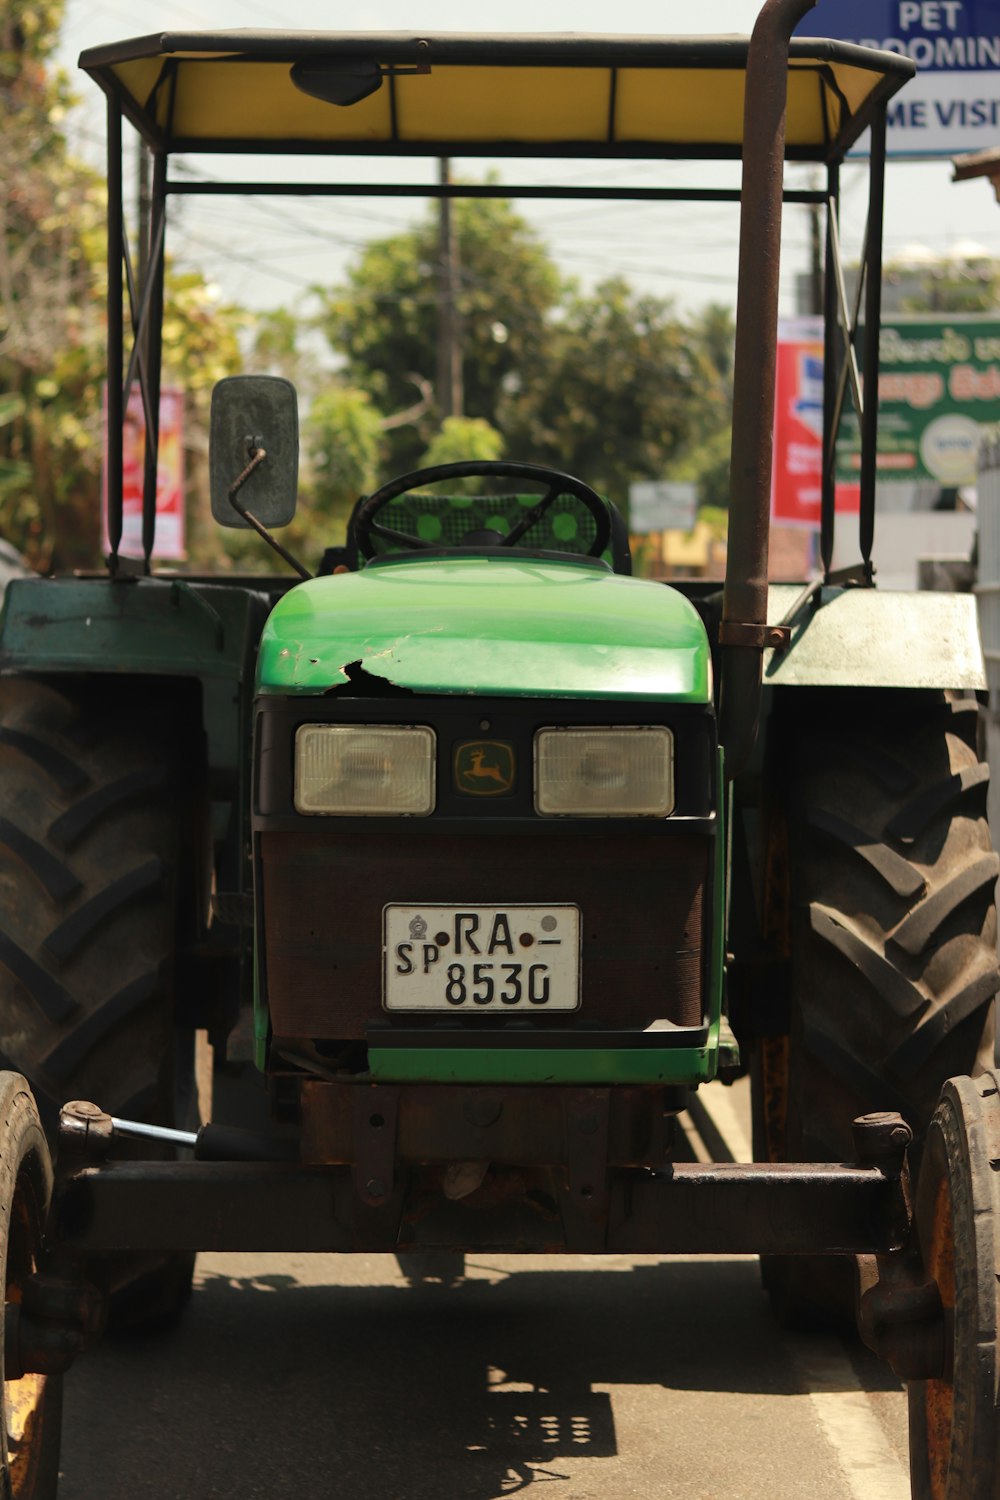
left=103, top=387, right=186, bottom=561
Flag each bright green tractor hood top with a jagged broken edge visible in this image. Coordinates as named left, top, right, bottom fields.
left=258, top=557, right=712, bottom=704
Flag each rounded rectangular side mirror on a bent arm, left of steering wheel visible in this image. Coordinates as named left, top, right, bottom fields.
left=208, top=375, right=298, bottom=530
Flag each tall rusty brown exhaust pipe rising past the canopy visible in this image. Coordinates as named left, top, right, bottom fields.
left=720, top=0, right=816, bottom=777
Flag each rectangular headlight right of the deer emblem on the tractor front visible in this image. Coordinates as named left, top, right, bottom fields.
left=535, top=725, right=673, bottom=818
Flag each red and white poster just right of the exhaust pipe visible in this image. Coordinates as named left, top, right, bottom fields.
left=771, top=318, right=861, bottom=530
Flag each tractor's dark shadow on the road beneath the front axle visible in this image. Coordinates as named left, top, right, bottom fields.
left=60, top=1256, right=898, bottom=1500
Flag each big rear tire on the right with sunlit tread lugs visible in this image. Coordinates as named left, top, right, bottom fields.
left=756, top=692, right=1000, bottom=1323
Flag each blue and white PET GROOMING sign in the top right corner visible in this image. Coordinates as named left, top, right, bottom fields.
left=801, top=0, right=1000, bottom=156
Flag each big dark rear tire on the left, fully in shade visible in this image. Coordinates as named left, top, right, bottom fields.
left=0, top=678, right=203, bottom=1323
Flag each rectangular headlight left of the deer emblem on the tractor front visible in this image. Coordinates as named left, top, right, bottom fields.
left=295, top=725, right=435, bottom=818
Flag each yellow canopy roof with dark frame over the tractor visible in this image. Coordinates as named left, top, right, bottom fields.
left=79, top=32, right=913, bottom=161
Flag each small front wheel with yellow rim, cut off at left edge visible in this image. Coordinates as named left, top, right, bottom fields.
left=0, top=1073, right=63, bottom=1500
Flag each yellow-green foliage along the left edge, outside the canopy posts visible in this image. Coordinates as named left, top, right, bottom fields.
left=0, top=0, right=103, bottom=567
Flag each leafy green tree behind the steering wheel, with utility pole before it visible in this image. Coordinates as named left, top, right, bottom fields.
left=319, top=200, right=733, bottom=525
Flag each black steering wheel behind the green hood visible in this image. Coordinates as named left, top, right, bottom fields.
left=354, top=459, right=612, bottom=558
